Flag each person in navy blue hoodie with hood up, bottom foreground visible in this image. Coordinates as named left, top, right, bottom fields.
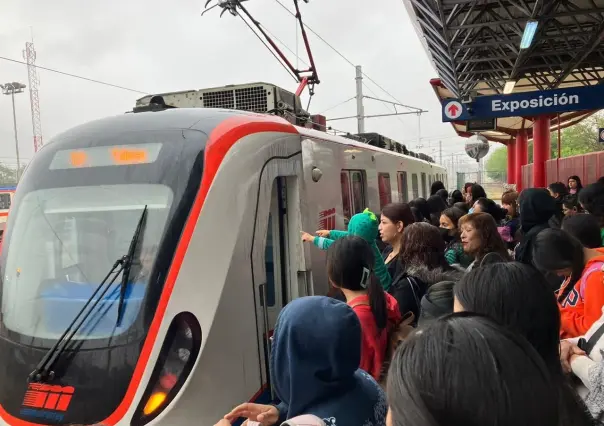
left=224, top=296, right=388, bottom=426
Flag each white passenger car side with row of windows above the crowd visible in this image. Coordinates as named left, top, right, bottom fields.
left=302, top=137, right=446, bottom=295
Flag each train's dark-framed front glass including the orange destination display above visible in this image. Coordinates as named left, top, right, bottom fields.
left=0, top=129, right=207, bottom=350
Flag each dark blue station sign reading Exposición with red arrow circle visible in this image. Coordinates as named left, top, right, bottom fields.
left=442, top=84, right=604, bottom=123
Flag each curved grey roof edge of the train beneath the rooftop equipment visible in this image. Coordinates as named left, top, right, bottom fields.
left=43, top=108, right=442, bottom=167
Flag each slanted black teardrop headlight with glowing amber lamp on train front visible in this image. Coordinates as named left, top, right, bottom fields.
left=131, top=312, right=201, bottom=426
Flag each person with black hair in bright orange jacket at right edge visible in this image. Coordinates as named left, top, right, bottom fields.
left=533, top=229, right=604, bottom=339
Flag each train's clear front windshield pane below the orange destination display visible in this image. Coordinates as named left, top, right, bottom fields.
left=2, top=184, right=174, bottom=339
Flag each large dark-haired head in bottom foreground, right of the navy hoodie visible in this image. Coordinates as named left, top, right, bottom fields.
left=386, top=313, right=591, bottom=426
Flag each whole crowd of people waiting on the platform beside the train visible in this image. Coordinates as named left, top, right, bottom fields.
left=217, top=176, right=604, bottom=426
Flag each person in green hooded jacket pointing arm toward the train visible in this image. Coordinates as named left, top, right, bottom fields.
left=302, top=209, right=392, bottom=290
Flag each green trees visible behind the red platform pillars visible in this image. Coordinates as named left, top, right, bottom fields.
left=485, top=114, right=604, bottom=175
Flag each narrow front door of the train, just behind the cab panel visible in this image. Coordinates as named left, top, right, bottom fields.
left=252, top=156, right=312, bottom=402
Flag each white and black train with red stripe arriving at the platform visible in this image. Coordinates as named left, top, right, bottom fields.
left=0, top=88, right=447, bottom=426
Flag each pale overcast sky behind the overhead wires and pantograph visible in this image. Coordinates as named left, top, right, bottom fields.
left=0, top=0, right=482, bottom=174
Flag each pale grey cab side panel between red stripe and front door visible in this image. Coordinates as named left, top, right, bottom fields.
left=124, top=133, right=310, bottom=426
